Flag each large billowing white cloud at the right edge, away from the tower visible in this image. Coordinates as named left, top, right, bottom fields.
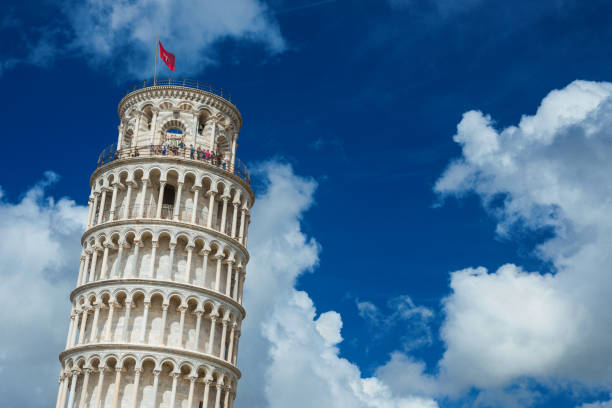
left=426, top=81, right=612, bottom=400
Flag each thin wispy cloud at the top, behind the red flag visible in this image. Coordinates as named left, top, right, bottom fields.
left=0, top=0, right=286, bottom=78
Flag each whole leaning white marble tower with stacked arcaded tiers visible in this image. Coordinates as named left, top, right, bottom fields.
left=56, top=80, right=254, bottom=408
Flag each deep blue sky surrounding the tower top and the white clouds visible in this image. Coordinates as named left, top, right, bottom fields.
left=0, top=0, right=612, bottom=407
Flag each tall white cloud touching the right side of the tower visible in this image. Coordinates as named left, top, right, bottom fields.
left=232, top=162, right=437, bottom=408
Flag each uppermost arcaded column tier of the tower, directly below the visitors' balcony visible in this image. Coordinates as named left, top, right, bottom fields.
left=87, top=161, right=252, bottom=246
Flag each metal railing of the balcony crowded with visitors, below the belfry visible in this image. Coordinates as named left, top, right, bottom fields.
left=96, top=144, right=251, bottom=184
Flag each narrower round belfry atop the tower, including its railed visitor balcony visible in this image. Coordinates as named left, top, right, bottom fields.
left=98, top=78, right=250, bottom=183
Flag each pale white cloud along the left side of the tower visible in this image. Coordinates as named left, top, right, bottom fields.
left=0, top=173, right=87, bottom=407
